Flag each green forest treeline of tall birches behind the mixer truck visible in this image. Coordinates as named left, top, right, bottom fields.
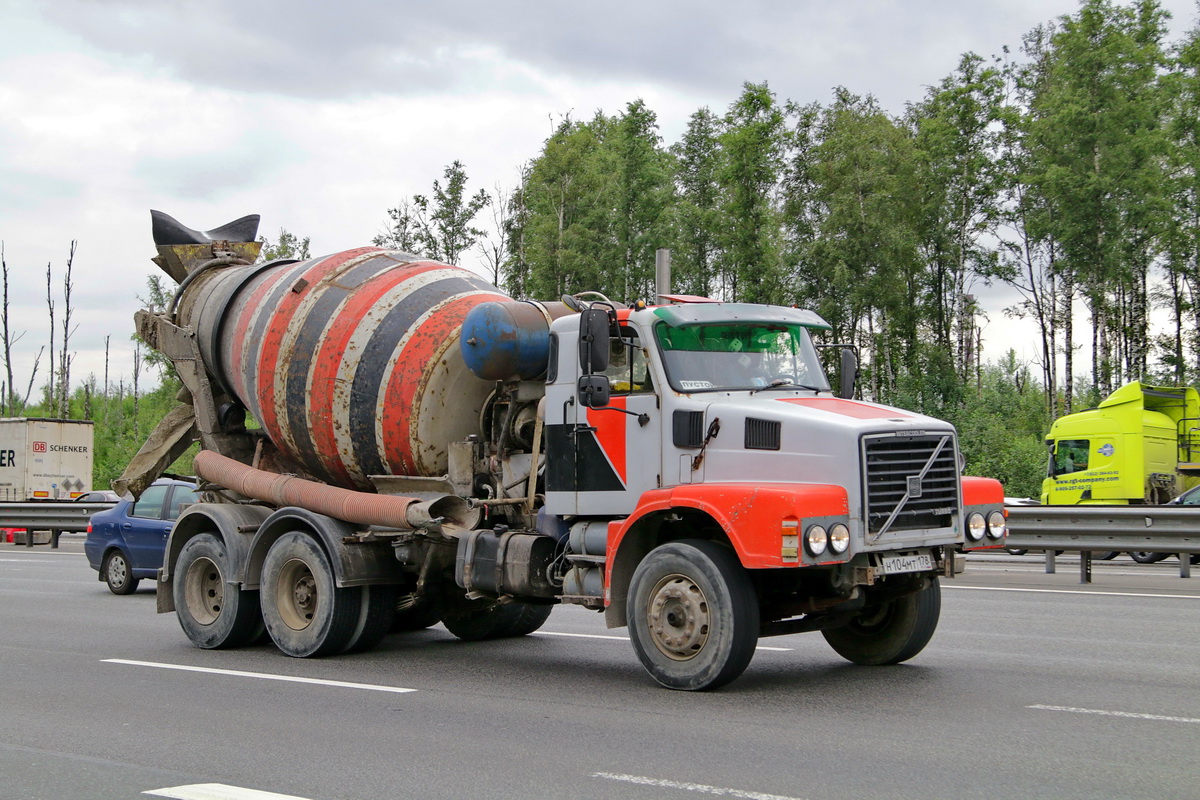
left=0, top=0, right=1200, bottom=495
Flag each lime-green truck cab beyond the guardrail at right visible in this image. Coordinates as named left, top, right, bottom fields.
left=1042, top=380, right=1200, bottom=505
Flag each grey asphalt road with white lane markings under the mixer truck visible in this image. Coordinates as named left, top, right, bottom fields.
left=0, top=536, right=1200, bottom=800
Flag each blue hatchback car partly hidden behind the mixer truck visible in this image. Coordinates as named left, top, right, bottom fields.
left=83, top=479, right=198, bottom=595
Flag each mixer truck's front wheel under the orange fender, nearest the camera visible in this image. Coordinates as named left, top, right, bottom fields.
left=626, top=540, right=758, bottom=691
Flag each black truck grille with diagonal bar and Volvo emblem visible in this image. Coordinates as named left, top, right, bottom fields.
left=863, top=433, right=959, bottom=536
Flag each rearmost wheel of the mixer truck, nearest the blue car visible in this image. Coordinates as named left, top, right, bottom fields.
left=172, top=534, right=263, bottom=650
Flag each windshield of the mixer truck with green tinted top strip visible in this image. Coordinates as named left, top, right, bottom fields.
left=654, top=321, right=829, bottom=392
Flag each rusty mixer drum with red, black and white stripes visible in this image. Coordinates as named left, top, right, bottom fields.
left=179, top=247, right=509, bottom=488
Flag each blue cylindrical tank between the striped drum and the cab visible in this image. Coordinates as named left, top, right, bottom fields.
left=460, top=300, right=574, bottom=380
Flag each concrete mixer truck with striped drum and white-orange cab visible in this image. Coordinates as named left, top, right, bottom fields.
left=116, top=212, right=1006, bottom=690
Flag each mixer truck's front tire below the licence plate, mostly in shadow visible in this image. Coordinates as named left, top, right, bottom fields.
left=822, top=578, right=942, bottom=667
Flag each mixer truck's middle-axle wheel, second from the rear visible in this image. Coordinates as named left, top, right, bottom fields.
left=259, top=531, right=364, bottom=658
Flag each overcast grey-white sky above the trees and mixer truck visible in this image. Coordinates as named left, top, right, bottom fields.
left=0, top=0, right=1195, bottom=395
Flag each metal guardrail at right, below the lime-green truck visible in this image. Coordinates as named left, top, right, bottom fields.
left=1004, top=505, right=1200, bottom=583
